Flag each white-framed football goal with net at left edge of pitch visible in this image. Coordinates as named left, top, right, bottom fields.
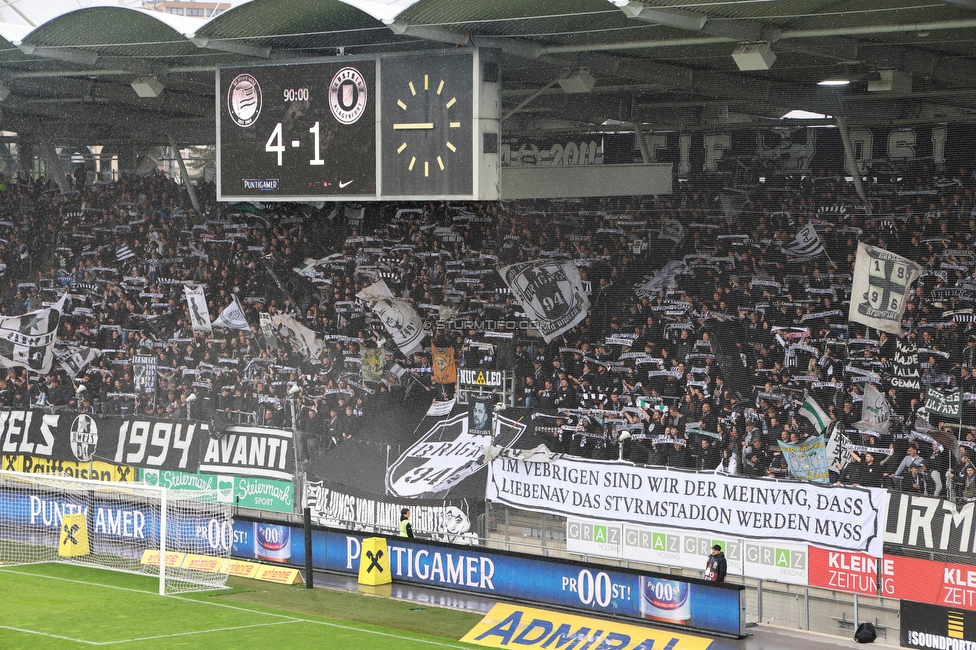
left=0, top=471, right=233, bottom=594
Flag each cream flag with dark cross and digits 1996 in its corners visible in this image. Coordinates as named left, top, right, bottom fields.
left=847, top=243, right=922, bottom=336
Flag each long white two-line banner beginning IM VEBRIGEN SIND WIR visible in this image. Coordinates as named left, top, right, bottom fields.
left=487, top=452, right=888, bottom=557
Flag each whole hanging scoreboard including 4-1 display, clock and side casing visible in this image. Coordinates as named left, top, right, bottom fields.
left=216, top=48, right=501, bottom=201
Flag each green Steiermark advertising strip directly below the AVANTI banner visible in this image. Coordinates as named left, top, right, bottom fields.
left=140, top=469, right=295, bottom=512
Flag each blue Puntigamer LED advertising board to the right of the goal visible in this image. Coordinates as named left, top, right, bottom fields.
left=232, top=520, right=745, bottom=636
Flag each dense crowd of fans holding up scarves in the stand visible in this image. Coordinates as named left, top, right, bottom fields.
left=0, top=158, right=976, bottom=498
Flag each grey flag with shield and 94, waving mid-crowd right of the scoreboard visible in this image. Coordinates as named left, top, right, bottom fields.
left=498, top=260, right=590, bottom=343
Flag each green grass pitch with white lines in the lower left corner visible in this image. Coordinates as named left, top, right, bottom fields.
left=0, top=564, right=481, bottom=650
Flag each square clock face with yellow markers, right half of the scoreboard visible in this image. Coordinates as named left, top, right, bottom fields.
left=380, top=53, right=474, bottom=196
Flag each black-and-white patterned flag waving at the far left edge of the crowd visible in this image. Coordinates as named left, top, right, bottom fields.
left=0, top=293, right=68, bottom=375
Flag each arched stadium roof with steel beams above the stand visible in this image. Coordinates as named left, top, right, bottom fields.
left=0, top=0, right=976, bottom=145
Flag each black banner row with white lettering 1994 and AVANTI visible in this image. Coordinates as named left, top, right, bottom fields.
left=0, top=409, right=294, bottom=481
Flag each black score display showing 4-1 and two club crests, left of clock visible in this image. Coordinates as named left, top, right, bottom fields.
left=217, top=57, right=376, bottom=201
